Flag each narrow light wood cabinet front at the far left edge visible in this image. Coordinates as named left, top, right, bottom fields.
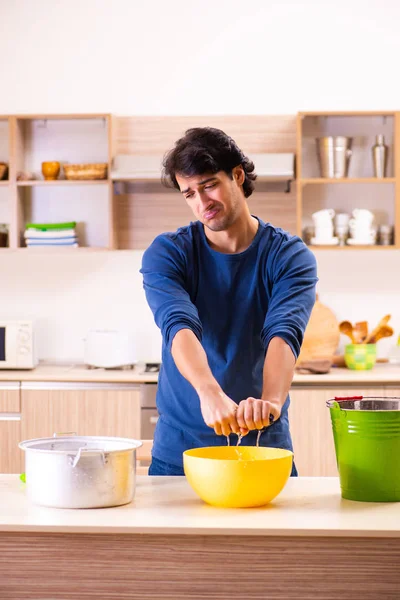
left=0, top=382, right=22, bottom=473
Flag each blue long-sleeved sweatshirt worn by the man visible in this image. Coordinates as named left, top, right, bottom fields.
left=141, top=219, right=317, bottom=466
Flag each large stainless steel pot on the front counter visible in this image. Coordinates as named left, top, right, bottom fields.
left=19, top=434, right=142, bottom=508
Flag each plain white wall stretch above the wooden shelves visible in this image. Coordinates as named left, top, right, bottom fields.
left=0, top=0, right=400, bottom=115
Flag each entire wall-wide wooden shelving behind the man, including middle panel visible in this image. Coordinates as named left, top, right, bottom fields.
left=0, top=111, right=400, bottom=254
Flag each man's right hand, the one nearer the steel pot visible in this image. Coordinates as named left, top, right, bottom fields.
left=198, top=385, right=248, bottom=436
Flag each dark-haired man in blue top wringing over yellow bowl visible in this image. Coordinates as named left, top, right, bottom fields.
left=141, top=127, right=317, bottom=475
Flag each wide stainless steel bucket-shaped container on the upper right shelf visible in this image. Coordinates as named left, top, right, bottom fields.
left=315, top=136, right=353, bottom=179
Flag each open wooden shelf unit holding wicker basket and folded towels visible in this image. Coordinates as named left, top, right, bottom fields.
left=0, top=114, right=114, bottom=252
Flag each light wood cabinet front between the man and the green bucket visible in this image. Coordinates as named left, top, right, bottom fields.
left=289, top=386, right=386, bottom=477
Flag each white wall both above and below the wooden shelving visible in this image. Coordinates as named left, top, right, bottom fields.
left=0, top=0, right=400, bottom=360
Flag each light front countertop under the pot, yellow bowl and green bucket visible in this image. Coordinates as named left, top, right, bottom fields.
left=0, top=475, right=400, bottom=538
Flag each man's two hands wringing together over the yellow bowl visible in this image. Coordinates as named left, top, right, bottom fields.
left=199, top=386, right=282, bottom=436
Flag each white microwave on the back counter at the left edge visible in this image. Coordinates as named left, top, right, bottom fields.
left=0, top=320, right=38, bottom=369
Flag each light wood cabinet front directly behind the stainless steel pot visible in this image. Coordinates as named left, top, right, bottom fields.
left=21, top=382, right=140, bottom=439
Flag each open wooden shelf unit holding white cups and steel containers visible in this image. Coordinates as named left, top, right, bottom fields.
left=296, top=111, right=400, bottom=250
